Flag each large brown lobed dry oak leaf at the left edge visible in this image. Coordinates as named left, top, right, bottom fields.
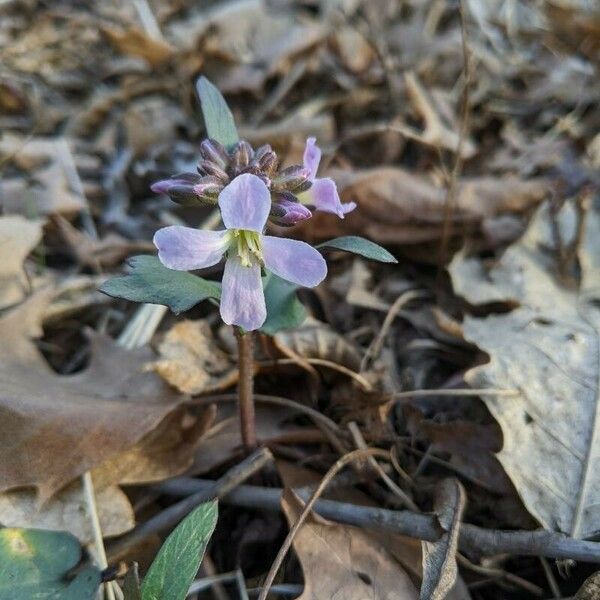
left=0, top=290, right=204, bottom=502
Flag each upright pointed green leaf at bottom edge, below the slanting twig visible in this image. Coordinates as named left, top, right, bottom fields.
left=142, top=502, right=217, bottom=600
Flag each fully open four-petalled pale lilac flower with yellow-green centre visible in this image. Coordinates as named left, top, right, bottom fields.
left=154, top=173, right=327, bottom=331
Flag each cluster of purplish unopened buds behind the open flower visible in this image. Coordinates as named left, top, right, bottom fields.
left=152, top=139, right=312, bottom=226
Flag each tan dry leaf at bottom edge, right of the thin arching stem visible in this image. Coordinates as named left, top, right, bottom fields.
left=281, top=489, right=417, bottom=600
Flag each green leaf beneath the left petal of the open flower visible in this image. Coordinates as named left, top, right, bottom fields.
left=100, top=256, right=221, bottom=314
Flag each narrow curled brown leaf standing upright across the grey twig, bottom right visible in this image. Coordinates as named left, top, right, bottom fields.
left=420, top=479, right=466, bottom=600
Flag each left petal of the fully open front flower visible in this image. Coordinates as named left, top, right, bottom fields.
left=153, top=225, right=228, bottom=271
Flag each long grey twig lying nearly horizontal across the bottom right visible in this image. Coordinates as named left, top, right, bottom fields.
left=159, top=477, right=600, bottom=563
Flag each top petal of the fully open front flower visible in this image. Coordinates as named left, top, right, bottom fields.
left=219, top=173, right=271, bottom=233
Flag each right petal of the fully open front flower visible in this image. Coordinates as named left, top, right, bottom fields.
left=262, top=235, right=327, bottom=287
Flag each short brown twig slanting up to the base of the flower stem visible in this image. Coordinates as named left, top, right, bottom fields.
left=109, top=448, right=273, bottom=557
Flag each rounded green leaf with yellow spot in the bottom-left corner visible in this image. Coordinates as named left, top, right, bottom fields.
left=0, top=528, right=100, bottom=600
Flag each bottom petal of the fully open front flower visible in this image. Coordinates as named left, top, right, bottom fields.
left=221, top=256, right=267, bottom=331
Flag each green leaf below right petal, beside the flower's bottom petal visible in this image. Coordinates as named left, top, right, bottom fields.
left=260, top=273, right=306, bottom=335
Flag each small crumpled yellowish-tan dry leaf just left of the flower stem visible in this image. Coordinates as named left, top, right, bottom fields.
left=147, top=320, right=238, bottom=394
